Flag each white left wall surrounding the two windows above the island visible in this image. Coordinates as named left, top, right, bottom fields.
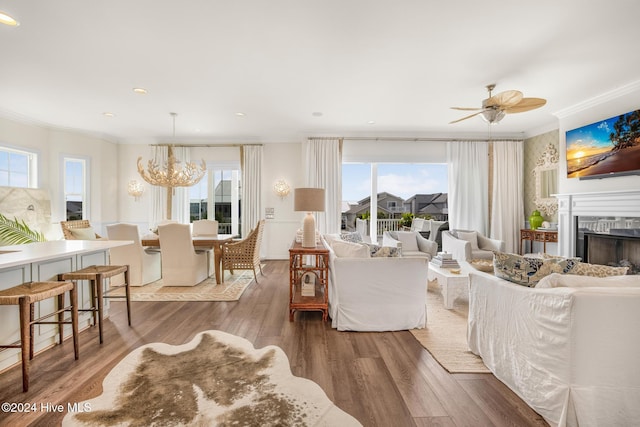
left=0, top=118, right=118, bottom=237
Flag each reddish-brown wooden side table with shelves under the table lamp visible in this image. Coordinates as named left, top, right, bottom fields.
left=289, top=241, right=329, bottom=322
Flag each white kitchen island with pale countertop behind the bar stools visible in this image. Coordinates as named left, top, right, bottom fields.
left=0, top=240, right=133, bottom=371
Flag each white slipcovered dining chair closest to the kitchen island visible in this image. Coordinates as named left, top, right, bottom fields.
left=106, top=224, right=162, bottom=286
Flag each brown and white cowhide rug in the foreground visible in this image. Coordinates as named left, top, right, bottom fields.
left=62, top=331, right=361, bottom=426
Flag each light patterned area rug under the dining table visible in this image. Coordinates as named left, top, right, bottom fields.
left=111, top=270, right=253, bottom=301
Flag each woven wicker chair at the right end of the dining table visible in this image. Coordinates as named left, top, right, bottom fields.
left=221, top=220, right=264, bottom=283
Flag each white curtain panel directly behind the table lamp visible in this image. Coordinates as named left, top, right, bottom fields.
left=305, top=138, right=342, bottom=234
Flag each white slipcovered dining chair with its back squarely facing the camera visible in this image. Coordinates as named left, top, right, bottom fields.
left=158, top=224, right=209, bottom=286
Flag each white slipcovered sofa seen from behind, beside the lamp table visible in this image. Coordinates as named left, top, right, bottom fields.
left=323, top=236, right=428, bottom=331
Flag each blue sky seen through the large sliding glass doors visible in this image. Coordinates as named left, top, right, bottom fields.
left=342, top=163, right=449, bottom=201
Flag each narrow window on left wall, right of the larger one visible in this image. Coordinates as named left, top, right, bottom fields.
left=63, top=157, right=89, bottom=221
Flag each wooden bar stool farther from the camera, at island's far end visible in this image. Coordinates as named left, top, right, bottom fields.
left=58, top=265, right=131, bottom=344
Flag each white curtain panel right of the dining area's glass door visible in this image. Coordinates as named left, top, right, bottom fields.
left=240, top=145, right=262, bottom=236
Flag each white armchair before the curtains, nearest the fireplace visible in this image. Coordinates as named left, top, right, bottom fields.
left=442, top=230, right=504, bottom=261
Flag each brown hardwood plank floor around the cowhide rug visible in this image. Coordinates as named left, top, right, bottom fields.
left=0, top=261, right=547, bottom=427
